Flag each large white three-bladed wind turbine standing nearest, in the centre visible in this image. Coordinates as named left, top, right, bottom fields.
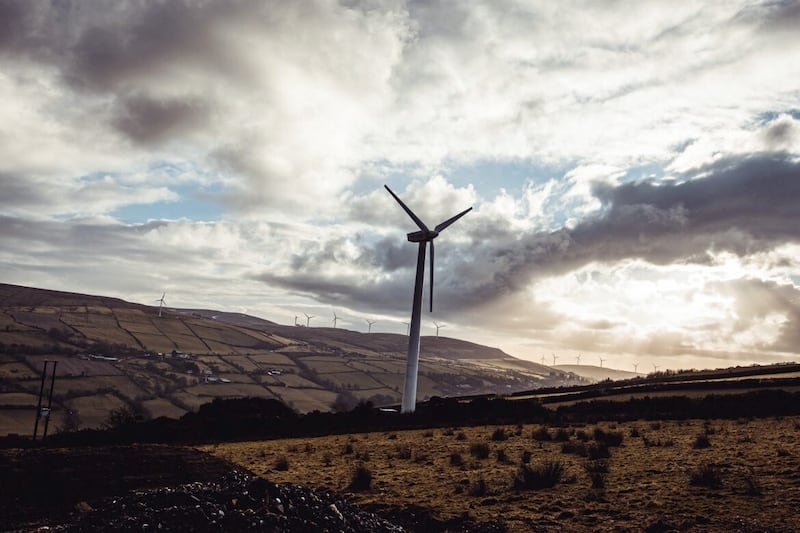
left=384, top=185, right=472, bottom=413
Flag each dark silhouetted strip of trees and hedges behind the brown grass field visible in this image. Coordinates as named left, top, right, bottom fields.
left=0, top=389, right=800, bottom=447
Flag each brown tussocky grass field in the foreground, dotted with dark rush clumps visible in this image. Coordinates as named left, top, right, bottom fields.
left=201, top=417, right=800, bottom=531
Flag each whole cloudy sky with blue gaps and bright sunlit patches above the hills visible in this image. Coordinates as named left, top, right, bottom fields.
left=0, top=0, right=800, bottom=371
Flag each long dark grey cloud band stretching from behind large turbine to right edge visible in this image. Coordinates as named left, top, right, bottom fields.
left=255, top=154, right=800, bottom=318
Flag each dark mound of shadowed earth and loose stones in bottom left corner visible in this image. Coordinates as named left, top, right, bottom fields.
left=0, top=445, right=504, bottom=533
